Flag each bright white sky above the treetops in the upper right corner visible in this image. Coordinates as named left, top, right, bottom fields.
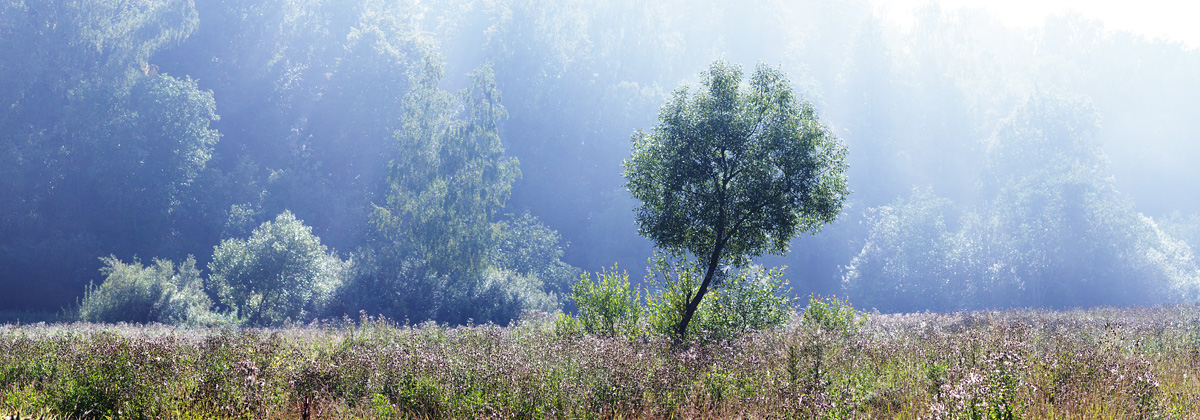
left=874, top=0, right=1200, bottom=49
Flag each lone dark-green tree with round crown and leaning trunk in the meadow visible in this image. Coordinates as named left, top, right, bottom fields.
left=624, top=61, right=850, bottom=337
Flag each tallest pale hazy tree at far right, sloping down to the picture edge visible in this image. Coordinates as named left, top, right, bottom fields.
left=971, top=91, right=1200, bottom=307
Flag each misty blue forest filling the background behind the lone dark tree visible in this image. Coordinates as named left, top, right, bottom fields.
left=0, top=0, right=1200, bottom=326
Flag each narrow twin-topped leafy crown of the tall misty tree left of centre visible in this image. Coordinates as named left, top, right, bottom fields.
left=373, top=63, right=521, bottom=288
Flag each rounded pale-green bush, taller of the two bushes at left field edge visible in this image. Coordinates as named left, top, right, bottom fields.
left=208, top=211, right=346, bottom=325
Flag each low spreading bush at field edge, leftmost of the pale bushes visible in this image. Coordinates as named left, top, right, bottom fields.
left=78, top=257, right=223, bottom=324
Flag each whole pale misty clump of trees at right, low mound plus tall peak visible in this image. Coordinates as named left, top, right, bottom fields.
left=844, top=94, right=1200, bottom=312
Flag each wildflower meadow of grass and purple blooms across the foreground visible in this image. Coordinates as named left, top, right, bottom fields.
left=0, top=305, right=1200, bottom=419
